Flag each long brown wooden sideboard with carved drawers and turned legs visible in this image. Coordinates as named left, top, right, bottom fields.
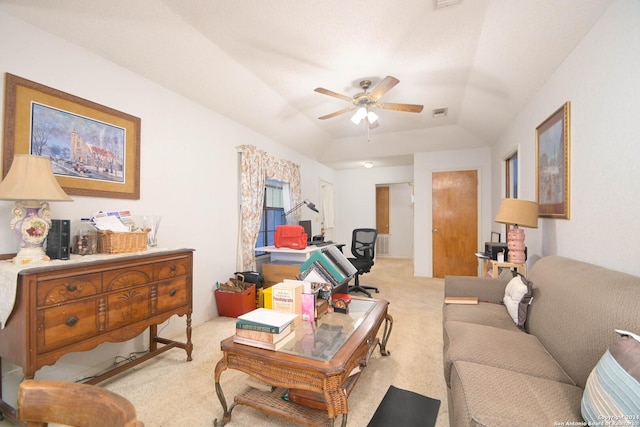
left=0, top=249, right=193, bottom=421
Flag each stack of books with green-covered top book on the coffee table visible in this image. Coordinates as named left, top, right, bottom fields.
left=233, top=308, right=299, bottom=351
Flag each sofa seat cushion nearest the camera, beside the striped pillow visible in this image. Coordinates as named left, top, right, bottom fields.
left=449, top=361, right=583, bottom=427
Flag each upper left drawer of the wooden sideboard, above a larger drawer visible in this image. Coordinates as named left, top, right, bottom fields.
left=37, top=273, right=102, bottom=307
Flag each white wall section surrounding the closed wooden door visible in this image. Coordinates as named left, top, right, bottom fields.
left=414, top=148, right=491, bottom=277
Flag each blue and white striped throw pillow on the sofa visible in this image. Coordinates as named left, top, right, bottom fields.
left=582, top=331, right=640, bottom=425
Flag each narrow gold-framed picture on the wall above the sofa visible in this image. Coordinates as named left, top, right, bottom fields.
left=536, top=101, right=571, bottom=219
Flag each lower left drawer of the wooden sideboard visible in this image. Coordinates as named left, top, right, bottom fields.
left=38, top=298, right=98, bottom=353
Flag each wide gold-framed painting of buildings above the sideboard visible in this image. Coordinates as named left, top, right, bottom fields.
left=2, top=73, right=141, bottom=200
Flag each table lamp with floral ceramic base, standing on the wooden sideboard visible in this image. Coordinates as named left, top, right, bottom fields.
left=0, top=154, right=72, bottom=264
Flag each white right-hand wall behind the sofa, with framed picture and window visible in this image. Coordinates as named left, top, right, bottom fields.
left=492, top=0, right=640, bottom=275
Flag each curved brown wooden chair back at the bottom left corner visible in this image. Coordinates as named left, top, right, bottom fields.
left=18, top=380, right=144, bottom=427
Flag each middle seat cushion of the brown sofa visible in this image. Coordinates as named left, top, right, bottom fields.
left=444, top=321, right=574, bottom=385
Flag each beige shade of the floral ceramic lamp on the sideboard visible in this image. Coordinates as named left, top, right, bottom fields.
left=0, top=154, right=72, bottom=202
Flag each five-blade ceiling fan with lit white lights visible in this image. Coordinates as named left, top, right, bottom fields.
left=315, top=76, right=424, bottom=129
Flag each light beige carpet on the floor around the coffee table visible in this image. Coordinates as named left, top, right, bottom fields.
left=0, top=258, right=449, bottom=427
